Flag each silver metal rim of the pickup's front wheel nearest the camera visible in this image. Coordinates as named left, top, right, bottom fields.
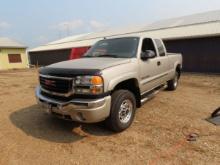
left=118, top=100, right=133, bottom=123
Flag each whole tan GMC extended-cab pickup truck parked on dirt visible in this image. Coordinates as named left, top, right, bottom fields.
left=36, top=36, right=182, bottom=132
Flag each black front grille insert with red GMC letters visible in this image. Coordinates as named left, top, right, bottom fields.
left=40, top=76, right=73, bottom=94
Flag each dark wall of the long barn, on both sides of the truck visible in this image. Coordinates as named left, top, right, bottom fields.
left=29, top=37, right=220, bottom=73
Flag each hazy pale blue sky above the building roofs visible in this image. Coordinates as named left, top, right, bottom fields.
left=0, top=0, right=220, bottom=48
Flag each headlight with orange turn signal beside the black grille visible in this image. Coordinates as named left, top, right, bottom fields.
left=73, top=76, right=104, bottom=95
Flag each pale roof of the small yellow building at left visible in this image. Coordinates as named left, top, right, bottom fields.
left=0, top=37, right=27, bottom=48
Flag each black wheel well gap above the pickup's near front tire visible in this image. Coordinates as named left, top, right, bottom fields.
left=112, top=78, right=141, bottom=108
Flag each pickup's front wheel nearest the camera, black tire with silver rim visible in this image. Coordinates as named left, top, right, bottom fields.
left=105, top=90, right=136, bottom=132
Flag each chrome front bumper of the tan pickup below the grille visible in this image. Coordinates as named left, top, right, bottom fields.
left=35, top=87, right=111, bottom=123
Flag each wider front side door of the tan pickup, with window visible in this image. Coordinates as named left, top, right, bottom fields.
left=139, top=38, right=161, bottom=94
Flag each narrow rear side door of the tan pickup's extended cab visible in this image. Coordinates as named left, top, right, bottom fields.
left=154, top=39, right=169, bottom=83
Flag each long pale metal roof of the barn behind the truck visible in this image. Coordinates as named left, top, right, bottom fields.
left=30, top=10, right=220, bottom=52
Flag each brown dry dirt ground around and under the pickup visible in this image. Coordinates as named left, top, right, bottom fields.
left=0, top=70, right=220, bottom=165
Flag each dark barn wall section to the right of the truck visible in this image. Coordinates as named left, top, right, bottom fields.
left=164, top=37, right=220, bottom=73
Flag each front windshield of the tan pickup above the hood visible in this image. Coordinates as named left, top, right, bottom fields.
left=83, top=37, right=139, bottom=58
